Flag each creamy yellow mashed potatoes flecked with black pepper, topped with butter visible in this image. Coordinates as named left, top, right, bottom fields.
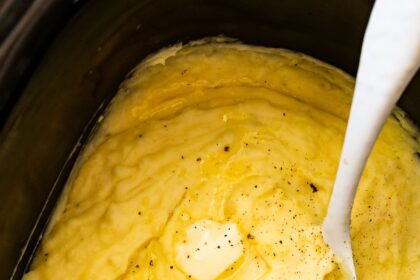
left=24, top=38, right=420, bottom=280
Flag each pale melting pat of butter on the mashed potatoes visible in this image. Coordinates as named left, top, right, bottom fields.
left=176, top=220, right=243, bottom=280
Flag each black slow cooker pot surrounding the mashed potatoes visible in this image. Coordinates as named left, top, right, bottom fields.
left=0, top=0, right=420, bottom=279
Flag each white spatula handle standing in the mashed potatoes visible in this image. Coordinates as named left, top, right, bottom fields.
left=323, top=0, right=420, bottom=279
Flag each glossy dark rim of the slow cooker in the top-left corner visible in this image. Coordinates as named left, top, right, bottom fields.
left=0, top=0, right=86, bottom=132
